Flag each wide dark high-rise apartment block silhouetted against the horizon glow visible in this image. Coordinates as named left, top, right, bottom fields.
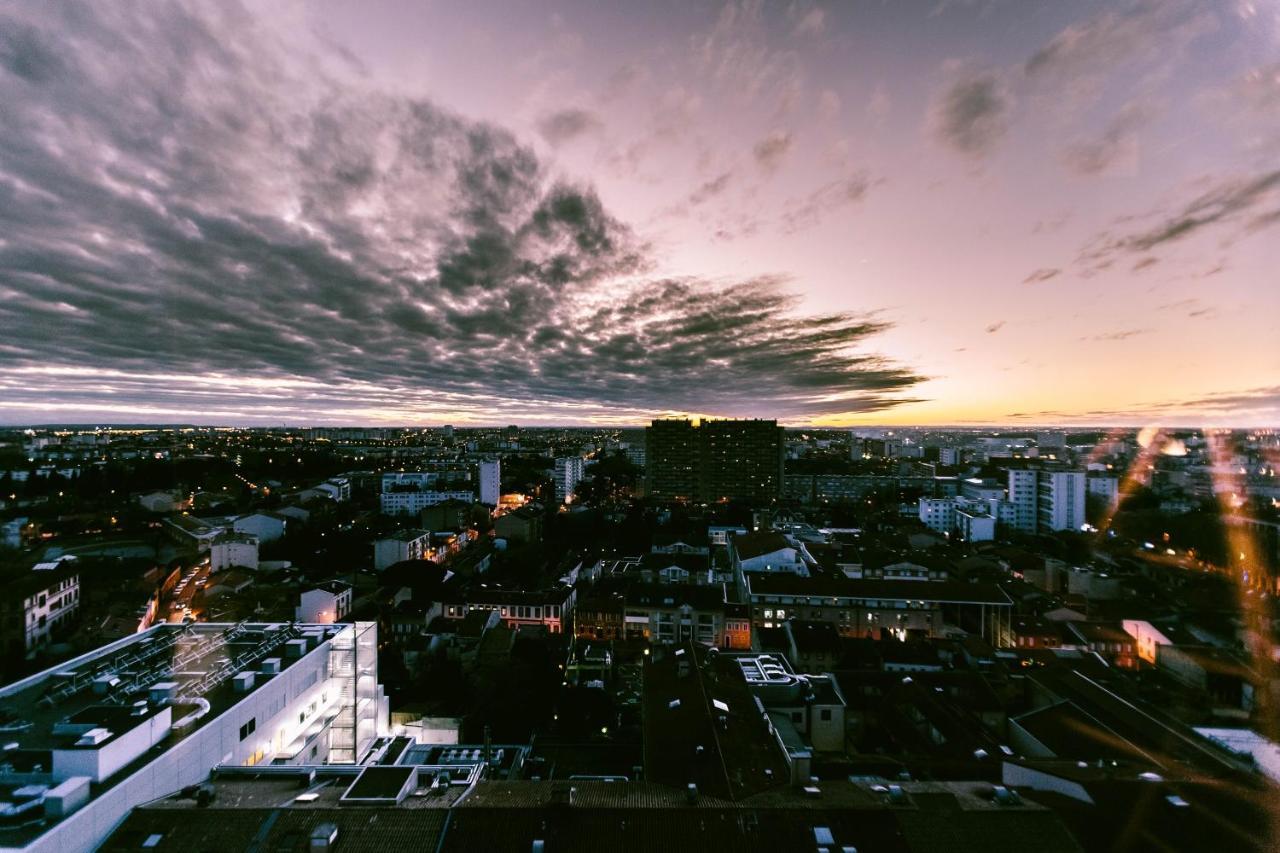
left=645, top=420, right=783, bottom=503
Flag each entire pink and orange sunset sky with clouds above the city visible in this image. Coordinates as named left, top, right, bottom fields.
left=0, top=0, right=1280, bottom=427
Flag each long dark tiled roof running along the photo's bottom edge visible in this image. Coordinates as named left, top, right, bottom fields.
left=101, top=768, right=1080, bottom=853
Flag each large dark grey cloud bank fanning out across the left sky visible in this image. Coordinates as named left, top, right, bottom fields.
left=0, top=4, right=919, bottom=423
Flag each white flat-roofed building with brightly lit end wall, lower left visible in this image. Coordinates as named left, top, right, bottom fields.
left=0, top=622, right=388, bottom=853
